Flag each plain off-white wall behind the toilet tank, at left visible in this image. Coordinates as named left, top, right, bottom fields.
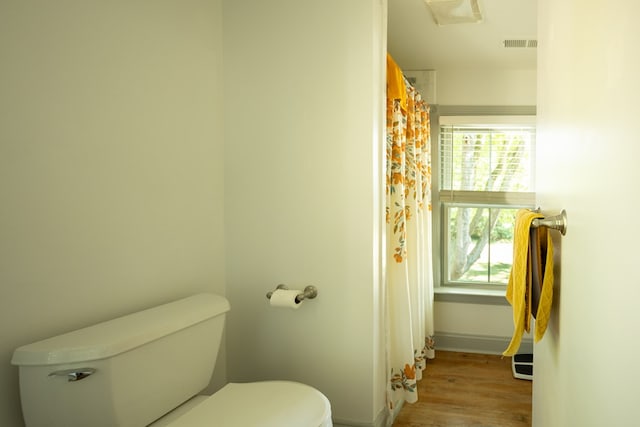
left=0, top=0, right=225, bottom=426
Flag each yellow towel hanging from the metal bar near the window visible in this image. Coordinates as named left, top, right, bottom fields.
left=502, top=209, right=553, bottom=356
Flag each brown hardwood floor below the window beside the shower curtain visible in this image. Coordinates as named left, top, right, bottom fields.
left=393, top=351, right=532, bottom=427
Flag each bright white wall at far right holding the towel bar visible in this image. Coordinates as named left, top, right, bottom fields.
left=533, top=0, right=640, bottom=427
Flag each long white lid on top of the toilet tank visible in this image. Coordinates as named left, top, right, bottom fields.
left=11, top=293, right=230, bottom=366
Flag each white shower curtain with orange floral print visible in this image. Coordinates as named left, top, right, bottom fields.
left=386, top=55, right=435, bottom=411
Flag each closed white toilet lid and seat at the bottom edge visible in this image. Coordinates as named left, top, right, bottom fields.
left=168, top=381, right=333, bottom=427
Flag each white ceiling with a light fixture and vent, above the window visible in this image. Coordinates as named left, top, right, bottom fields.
left=387, top=0, right=538, bottom=70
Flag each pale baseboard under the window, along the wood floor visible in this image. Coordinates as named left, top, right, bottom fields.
left=435, top=331, right=533, bottom=355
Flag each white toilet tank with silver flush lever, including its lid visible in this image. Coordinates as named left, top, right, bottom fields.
left=11, top=294, right=229, bottom=427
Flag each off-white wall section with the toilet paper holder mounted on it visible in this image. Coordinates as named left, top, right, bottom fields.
left=224, top=0, right=386, bottom=425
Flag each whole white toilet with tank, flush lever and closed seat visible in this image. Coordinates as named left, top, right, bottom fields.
left=11, top=294, right=332, bottom=427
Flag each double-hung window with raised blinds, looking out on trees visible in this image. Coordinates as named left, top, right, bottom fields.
left=437, top=116, right=535, bottom=289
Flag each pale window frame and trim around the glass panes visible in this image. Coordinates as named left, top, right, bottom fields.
left=430, top=105, right=536, bottom=304
